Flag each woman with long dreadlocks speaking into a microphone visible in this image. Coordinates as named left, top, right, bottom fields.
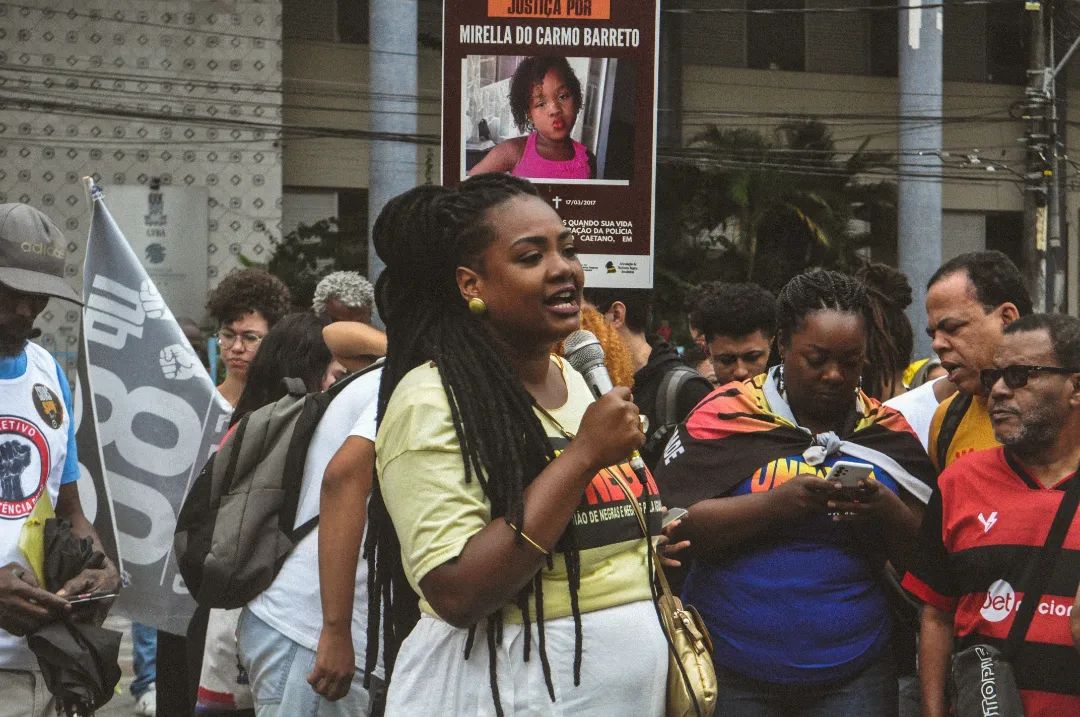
left=367, top=174, right=667, bottom=717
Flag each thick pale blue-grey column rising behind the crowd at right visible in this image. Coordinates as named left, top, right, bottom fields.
left=896, top=0, right=944, bottom=356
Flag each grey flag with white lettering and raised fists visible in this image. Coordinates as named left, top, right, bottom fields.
left=80, top=180, right=230, bottom=634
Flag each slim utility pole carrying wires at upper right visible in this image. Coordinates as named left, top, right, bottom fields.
left=1023, top=2, right=1056, bottom=307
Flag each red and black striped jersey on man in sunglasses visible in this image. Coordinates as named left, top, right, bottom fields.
left=903, top=447, right=1080, bottom=717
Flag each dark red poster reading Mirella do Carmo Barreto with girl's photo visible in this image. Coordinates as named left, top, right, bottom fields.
left=442, top=0, right=659, bottom=288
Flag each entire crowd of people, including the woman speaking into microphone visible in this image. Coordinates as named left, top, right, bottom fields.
left=0, top=174, right=1080, bottom=717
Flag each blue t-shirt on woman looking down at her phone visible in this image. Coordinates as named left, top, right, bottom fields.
left=683, top=455, right=899, bottom=685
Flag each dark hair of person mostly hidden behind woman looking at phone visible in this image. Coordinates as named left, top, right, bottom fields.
left=855, top=263, right=915, bottom=401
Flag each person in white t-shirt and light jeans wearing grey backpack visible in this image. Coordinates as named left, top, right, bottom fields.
left=238, top=324, right=386, bottom=717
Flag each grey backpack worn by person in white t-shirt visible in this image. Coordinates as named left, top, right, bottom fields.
left=173, top=362, right=381, bottom=608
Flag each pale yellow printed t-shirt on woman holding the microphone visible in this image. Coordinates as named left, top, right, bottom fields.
left=375, top=362, right=660, bottom=622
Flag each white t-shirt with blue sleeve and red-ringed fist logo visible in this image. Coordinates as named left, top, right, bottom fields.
left=0, top=343, right=79, bottom=669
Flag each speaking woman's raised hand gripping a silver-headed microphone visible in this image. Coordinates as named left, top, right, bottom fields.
left=563, top=330, right=645, bottom=472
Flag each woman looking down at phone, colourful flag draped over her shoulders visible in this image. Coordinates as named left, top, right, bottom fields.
left=657, top=270, right=934, bottom=717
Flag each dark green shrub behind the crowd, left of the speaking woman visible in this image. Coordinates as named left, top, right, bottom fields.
left=240, top=217, right=367, bottom=309
